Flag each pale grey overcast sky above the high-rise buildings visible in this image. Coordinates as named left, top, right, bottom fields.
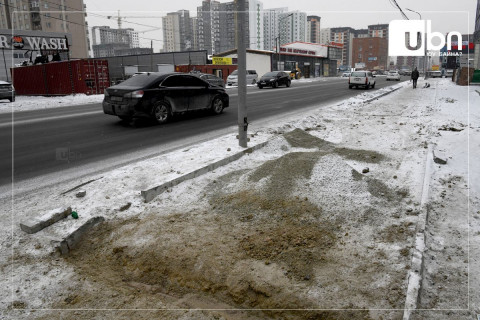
left=84, top=0, right=477, bottom=52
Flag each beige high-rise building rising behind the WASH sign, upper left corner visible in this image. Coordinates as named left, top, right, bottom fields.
left=0, top=0, right=89, bottom=58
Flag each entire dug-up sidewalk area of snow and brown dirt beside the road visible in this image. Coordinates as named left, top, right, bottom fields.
left=1, top=79, right=480, bottom=319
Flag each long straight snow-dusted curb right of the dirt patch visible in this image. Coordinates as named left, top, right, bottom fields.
left=403, top=145, right=433, bottom=320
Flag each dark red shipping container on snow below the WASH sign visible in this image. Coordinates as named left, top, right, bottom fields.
left=10, top=59, right=110, bottom=96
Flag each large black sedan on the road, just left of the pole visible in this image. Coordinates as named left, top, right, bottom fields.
left=103, top=72, right=229, bottom=123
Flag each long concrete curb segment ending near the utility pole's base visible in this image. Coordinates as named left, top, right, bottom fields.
left=141, top=141, right=268, bottom=202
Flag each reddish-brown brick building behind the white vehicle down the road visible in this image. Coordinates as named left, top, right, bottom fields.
left=350, top=37, right=389, bottom=70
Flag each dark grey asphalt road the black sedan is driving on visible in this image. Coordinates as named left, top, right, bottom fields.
left=0, top=77, right=408, bottom=186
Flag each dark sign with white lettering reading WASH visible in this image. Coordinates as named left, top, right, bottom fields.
left=0, top=34, right=68, bottom=51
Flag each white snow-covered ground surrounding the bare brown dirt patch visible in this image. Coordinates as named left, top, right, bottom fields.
left=0, top=79, right=480, bottom=319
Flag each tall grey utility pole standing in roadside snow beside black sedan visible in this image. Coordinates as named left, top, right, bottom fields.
left=236, top=0, right=248, bottom=148
